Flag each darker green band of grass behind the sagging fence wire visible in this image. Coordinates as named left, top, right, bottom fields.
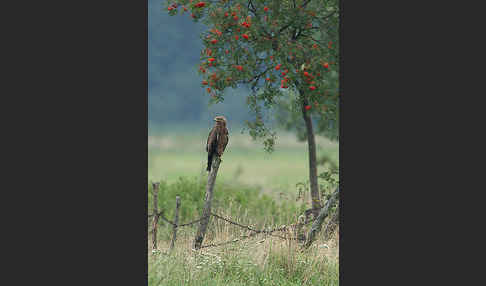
left=148, top=177, right=310, bottom=230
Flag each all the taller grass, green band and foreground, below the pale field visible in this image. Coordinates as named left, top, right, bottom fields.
left=148, top=178, right=339, bottom=285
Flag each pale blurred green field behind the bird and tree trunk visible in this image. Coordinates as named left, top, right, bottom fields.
left=148, top=129, right=339, bottom=192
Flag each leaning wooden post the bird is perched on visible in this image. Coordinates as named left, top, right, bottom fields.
left=194, top=156, right=221, bottom=249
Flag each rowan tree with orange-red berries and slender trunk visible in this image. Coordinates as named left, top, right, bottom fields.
left=167, top=0, right=339, bottom=213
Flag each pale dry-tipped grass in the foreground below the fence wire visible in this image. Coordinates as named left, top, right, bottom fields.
left=148, top=208, right=339, bottom=285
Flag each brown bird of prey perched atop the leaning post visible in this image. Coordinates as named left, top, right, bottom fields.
left=206, top=116, right=228, bottom=172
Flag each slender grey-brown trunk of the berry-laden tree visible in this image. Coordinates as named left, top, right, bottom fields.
left=299, top=96, right=321, bottom=217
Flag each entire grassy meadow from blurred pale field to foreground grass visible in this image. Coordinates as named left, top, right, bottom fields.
left=148, top=127, right=339, bottom=286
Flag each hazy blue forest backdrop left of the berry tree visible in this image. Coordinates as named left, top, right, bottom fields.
left=148, top=0, right=254, bottom=135
